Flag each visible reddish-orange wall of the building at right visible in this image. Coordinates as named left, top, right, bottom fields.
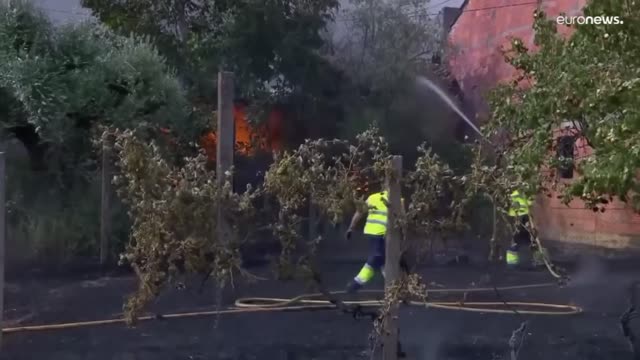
left=449, top=0, right=640, bottom=249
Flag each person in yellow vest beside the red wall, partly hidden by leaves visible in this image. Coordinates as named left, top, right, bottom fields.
left=506, top=190, right=538, bottom=267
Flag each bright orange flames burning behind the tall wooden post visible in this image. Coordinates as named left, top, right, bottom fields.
left=200, top=104, right=283, bottom=160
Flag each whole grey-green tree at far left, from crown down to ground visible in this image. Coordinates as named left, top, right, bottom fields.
left=0, top=1, right=192, bottom=260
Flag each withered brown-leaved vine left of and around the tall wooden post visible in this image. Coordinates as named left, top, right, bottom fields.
left=105, top=130, right=260, bottom=322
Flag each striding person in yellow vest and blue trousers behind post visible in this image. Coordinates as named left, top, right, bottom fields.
left=346, top=186, right=407, bottom=293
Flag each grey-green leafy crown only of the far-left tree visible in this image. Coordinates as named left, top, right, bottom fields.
left=0, top=3, right=194, bottom=165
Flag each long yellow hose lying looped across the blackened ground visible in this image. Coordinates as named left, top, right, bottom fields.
left=2, top=283, right=582, bottom=333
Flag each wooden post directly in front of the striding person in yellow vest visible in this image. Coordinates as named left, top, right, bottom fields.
left=382, top=156, right=402, bottom=360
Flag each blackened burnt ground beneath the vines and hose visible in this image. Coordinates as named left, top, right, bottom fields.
left=0, top=263, right=640, bottom=360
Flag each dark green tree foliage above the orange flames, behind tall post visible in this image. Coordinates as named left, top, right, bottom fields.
left=83, top=0, right=348, bottom=128
